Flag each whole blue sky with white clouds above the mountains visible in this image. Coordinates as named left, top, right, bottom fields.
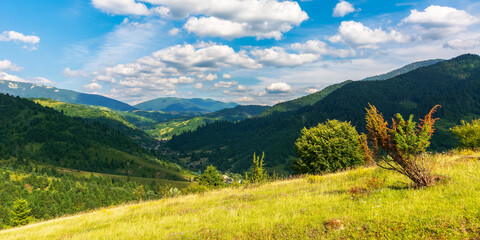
left=0, top=0, right=480, bottom=105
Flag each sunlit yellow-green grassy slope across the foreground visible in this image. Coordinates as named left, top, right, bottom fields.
left=0, top=153, right=480, bottom=240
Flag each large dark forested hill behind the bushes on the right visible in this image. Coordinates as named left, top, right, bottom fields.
left=169, top=54, right=480, bottom=172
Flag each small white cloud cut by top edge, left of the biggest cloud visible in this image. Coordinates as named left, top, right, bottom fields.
left=92, top=0, right=151, bottom=15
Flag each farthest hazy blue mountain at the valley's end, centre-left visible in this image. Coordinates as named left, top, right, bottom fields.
left=134, top=97, right=238, bottom=112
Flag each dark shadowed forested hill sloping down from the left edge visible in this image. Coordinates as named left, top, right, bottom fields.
left=0, top=94, right=187, bottom=180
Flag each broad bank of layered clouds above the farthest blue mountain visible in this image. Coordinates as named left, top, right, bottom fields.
left=84, top=42, right=262, bottom=100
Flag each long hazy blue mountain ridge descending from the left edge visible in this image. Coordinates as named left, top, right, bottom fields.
left=0, top=79, right=135, bottom=111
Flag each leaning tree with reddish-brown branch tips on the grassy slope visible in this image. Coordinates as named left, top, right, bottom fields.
left=365, top=104, right=440, bottom=187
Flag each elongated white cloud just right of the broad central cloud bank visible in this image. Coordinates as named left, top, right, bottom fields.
left=251, top=47, right=319, bottom=67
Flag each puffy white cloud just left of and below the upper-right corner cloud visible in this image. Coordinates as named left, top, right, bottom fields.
left=329, top=21, right=411, bottom=49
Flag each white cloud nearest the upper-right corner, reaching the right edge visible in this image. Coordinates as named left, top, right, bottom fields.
left=402, top=5, right=480, bottom=39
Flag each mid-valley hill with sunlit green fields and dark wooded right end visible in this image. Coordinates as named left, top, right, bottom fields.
left=144, top=105, right=269, bottom=139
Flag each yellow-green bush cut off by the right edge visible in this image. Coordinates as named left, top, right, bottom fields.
left=450, top=119, right=480, bottom=149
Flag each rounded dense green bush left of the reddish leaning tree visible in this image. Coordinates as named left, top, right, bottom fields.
left=292, top=120, right=364, bottom=174
